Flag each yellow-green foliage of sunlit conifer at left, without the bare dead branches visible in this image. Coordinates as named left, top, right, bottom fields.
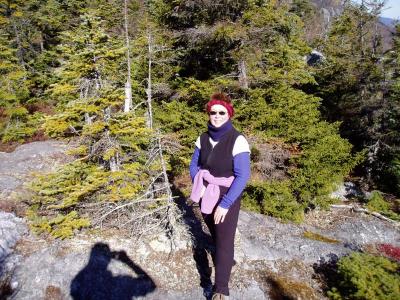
left=31, top=13, right=158, bottom=238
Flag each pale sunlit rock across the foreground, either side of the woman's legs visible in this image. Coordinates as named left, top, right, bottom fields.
left=7, top=206, right=400, bottom=299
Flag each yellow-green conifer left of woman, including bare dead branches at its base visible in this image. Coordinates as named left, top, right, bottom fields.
left=22, top=1, right=182, bottom=238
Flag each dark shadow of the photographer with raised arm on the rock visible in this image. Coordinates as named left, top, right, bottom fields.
left=70, top=243, right=156, bottom=300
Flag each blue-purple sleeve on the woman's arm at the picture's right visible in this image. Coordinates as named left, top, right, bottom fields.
left=219, top=152, right=250, bottom=208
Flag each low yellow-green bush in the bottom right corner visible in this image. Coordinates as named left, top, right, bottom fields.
left=328, top=253, right=400, bottom=300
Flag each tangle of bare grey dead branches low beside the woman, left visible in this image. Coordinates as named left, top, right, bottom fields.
left=80, top=133, right=187, bottom=238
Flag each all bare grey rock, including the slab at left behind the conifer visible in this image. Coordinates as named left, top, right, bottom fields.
left=0, top=142, right=400, bottom=300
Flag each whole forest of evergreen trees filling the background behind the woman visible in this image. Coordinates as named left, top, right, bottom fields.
left=0, top=0, right=400, bottom=237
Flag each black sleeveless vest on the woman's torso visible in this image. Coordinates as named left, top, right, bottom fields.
left=200, top=128, right=240, bottom=177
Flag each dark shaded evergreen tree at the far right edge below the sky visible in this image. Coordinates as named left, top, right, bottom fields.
left=316, top=1, right=397, bottom=197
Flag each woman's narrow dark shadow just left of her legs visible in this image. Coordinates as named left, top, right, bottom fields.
left=173, top=187, right=214, bottom=299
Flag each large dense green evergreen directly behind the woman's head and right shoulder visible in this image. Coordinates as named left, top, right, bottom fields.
left=149, top=1, right=358, bottom=220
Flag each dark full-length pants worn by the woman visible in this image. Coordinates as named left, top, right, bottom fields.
left=203, top=199, right=240, bottom=296
